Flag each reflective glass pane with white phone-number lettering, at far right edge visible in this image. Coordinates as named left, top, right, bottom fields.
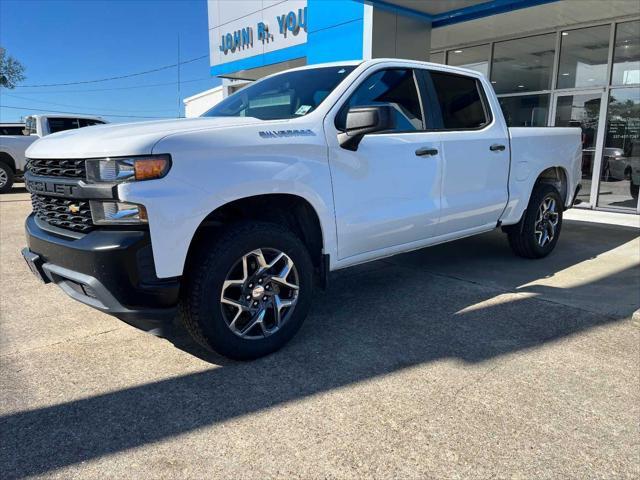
left=598, top=88, right=640, bottom=210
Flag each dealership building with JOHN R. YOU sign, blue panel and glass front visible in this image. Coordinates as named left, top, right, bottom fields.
left=205, top=0, right=640, bottom=214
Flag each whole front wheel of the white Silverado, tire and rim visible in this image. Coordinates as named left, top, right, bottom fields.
left=182, top=222, right=313, bottom=360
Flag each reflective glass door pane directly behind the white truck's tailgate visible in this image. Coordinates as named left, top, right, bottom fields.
left=555, top=93, right=601, bottom=202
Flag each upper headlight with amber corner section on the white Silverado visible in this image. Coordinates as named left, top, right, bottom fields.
left=86, top=155, right=171, bottom=183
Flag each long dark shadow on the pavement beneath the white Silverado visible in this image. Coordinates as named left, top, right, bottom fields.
left=0, top=222, right=640, bottom=478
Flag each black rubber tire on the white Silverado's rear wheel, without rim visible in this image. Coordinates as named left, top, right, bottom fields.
left=505, top=183, right=564, bottom=258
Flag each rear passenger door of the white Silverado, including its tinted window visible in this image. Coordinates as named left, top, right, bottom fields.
left=421, top=69, right=510, bottom=235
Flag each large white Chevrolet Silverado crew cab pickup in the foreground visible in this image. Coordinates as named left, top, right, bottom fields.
left=23, top=59, right=581, bottom=359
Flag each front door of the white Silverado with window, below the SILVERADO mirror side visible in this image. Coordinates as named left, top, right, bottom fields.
left=325, top=68, right=442, bottom=260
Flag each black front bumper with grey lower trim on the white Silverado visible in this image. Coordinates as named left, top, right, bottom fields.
left=23, top=214, right=180, bottom=334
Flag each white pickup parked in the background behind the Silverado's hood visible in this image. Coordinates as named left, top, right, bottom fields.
left=0, top=115, right=106, bottom=193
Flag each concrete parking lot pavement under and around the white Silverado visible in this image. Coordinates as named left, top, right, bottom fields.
left=0, top=189, right=640, bottom=479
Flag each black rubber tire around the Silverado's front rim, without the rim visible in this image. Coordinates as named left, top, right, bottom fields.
left=181, top=222, right=313, bottom=360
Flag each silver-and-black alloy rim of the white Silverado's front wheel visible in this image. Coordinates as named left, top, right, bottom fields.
left=220, top=248, right=300, bottom=340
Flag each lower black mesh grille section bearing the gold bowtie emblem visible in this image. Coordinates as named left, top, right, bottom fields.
left=31, top=193, right=94, bottom=233
